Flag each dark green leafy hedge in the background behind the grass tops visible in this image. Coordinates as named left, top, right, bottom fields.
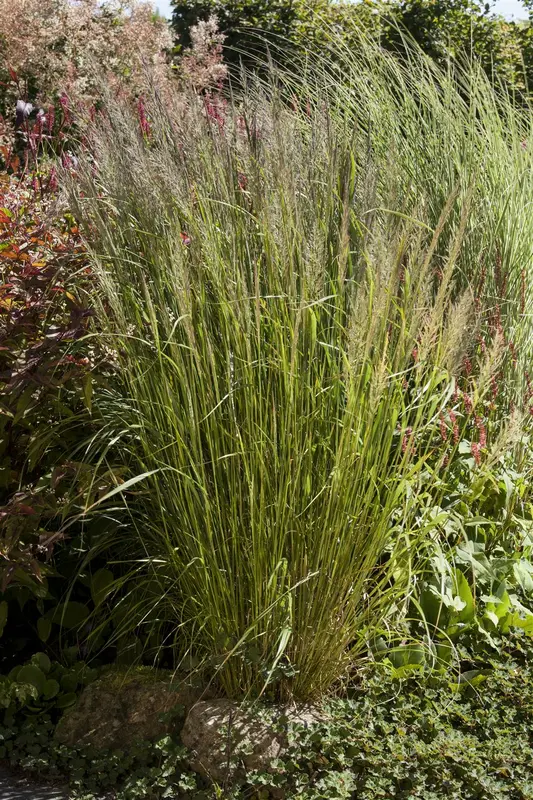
left=172, top=0, right=533, bottom=91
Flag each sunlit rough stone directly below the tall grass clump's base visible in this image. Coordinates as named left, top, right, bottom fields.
left=181, top=700, right=324, bottom=784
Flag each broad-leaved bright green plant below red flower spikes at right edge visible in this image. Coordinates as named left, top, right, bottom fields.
left=414, top=450, right=533, bottom=651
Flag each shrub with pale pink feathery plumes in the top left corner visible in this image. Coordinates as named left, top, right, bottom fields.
left=0, top=0, right=171, bottom=113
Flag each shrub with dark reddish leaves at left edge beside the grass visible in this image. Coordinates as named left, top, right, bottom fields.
left=0, top=175, right=92, bottom=591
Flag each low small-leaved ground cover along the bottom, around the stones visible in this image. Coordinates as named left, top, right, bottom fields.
left=0, top=635, right=533, bottom=800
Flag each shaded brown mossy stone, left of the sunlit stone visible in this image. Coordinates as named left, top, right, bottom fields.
left=55, top=668, right=200, bottom=750
